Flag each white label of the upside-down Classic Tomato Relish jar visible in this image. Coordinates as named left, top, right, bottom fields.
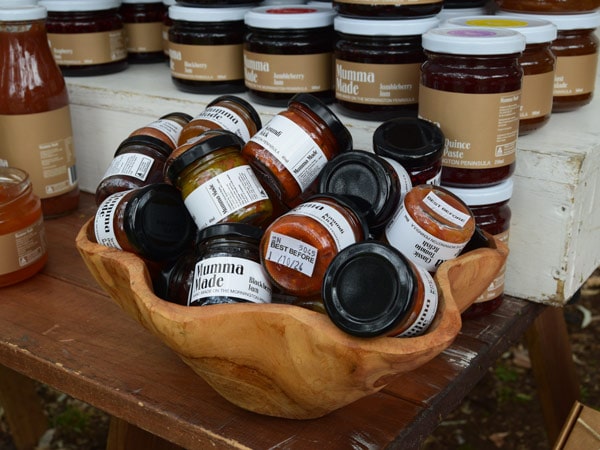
left=385, top=203, right=466, bottom=272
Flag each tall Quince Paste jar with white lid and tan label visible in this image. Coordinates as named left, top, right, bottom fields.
left=419, top=27, right=525, bottom=187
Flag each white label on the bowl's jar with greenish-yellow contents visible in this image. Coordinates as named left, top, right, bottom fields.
left=184, top=165, right=269, bottom=230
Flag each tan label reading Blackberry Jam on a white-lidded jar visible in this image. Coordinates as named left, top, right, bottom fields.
left=169, top=42, right=244, bottom=81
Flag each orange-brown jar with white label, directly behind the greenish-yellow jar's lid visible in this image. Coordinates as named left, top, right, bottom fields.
left=179, top=95, right=262, bottom=145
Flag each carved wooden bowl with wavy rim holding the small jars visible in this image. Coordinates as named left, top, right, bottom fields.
left=76, top=220, right=508, bottom=419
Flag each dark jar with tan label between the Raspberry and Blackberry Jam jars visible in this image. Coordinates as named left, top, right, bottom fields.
left=119, top=0, right=167, bottom=64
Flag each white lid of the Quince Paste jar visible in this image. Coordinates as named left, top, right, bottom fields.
left=422, top=27, right=525, bottom=55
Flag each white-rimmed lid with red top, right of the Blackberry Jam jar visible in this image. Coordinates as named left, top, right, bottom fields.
left=244, top=4, right=336, bottom=29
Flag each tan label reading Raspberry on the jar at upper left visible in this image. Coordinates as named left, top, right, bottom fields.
left=48, top=29, right=127, bottom=66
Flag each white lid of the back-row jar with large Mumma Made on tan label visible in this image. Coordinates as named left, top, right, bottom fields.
left=333, top=16, right=440, bottom=36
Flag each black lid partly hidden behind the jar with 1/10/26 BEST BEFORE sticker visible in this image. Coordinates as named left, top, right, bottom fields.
left=317, top=150, right=402, bottom=233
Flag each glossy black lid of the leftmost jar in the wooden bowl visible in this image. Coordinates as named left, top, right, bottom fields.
left=123, top=183, right=196, bottom=261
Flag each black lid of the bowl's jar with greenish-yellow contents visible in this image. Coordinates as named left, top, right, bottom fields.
left=167, top=129, right=244, bottom=182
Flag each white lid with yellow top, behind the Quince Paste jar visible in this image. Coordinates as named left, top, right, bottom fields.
left=441, top=15, right=557, bottom=44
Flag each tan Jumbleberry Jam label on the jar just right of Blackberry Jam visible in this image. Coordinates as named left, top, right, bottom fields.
left=244, top=50, right=333, bottom=94
